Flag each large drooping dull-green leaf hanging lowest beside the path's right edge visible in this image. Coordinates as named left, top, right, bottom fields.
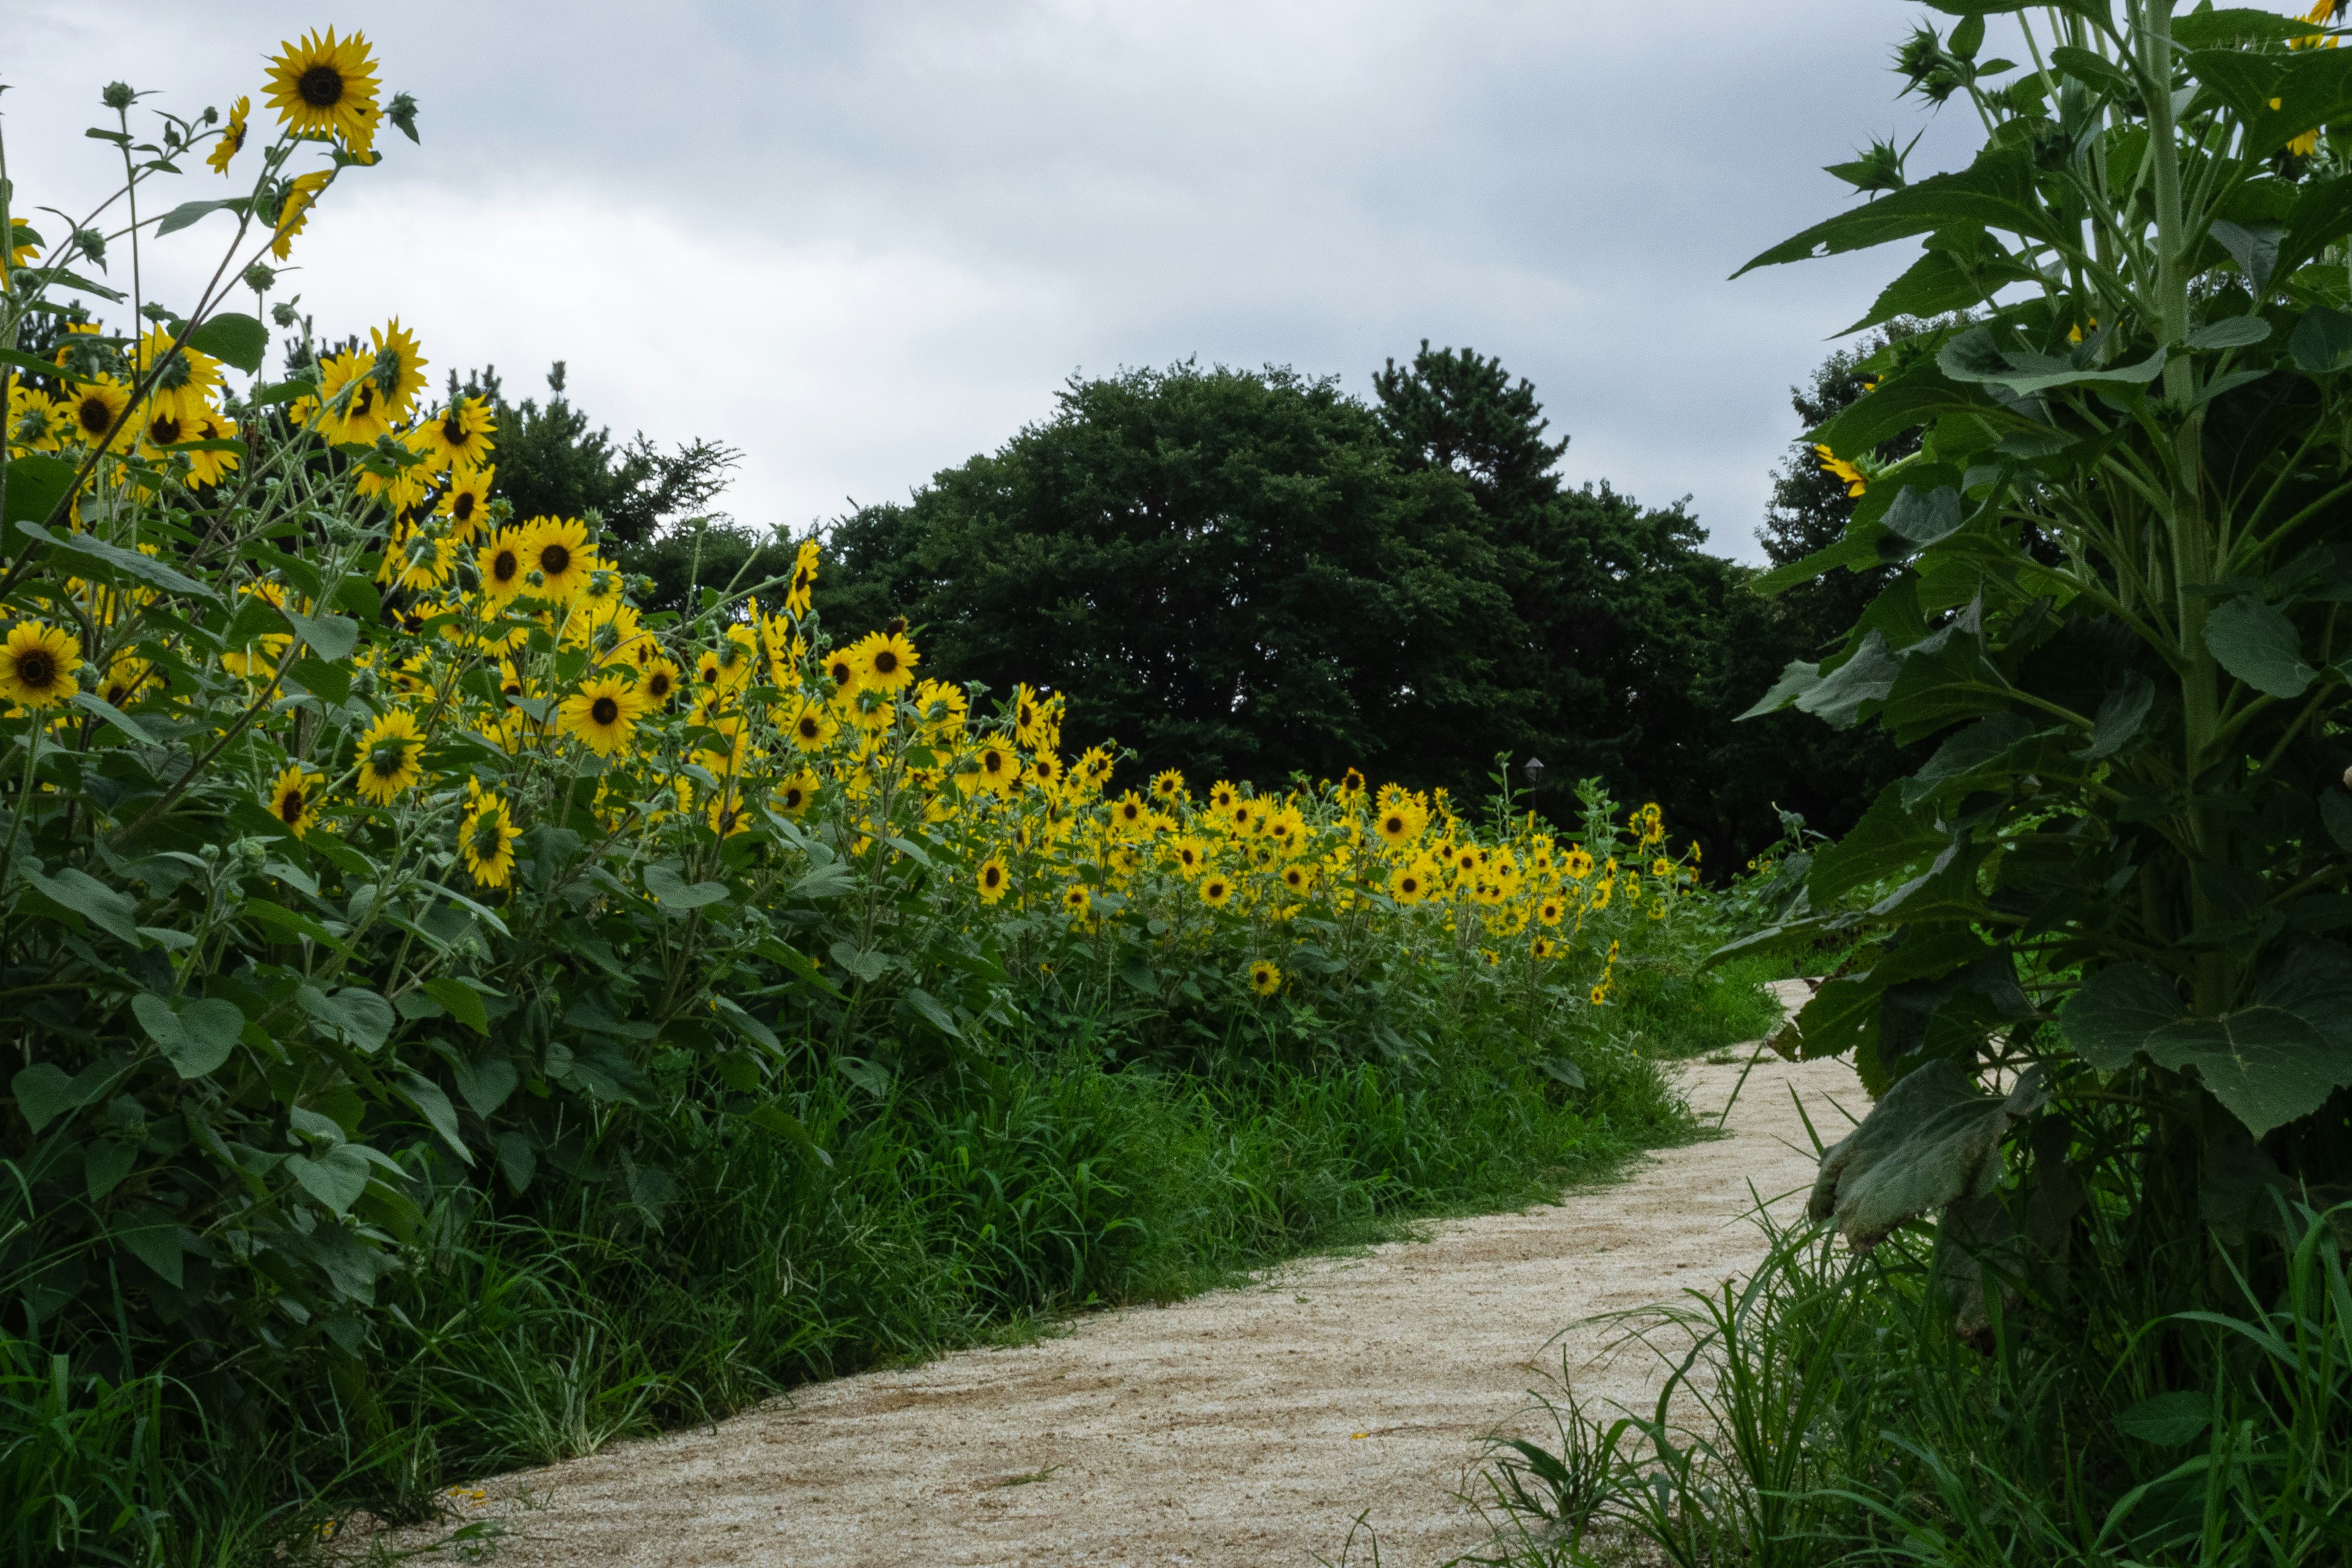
left=1804, top=1060, right=2046, bottom=1251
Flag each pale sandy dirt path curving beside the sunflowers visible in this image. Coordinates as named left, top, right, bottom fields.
left=418, top=987, right=1863, bottom=1568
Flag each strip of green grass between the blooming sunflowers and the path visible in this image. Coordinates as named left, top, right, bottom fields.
left=0, top=964, right=1776, bottom=1568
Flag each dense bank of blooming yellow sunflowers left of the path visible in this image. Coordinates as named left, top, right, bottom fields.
left=0, top=33, right=1696, bottom=1408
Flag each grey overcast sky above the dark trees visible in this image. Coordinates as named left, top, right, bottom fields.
left=0, top=0, right=1969, bottom=559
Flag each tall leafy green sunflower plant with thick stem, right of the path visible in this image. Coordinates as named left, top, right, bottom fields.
left=1741, top=0, right=2352, bottom=1326
